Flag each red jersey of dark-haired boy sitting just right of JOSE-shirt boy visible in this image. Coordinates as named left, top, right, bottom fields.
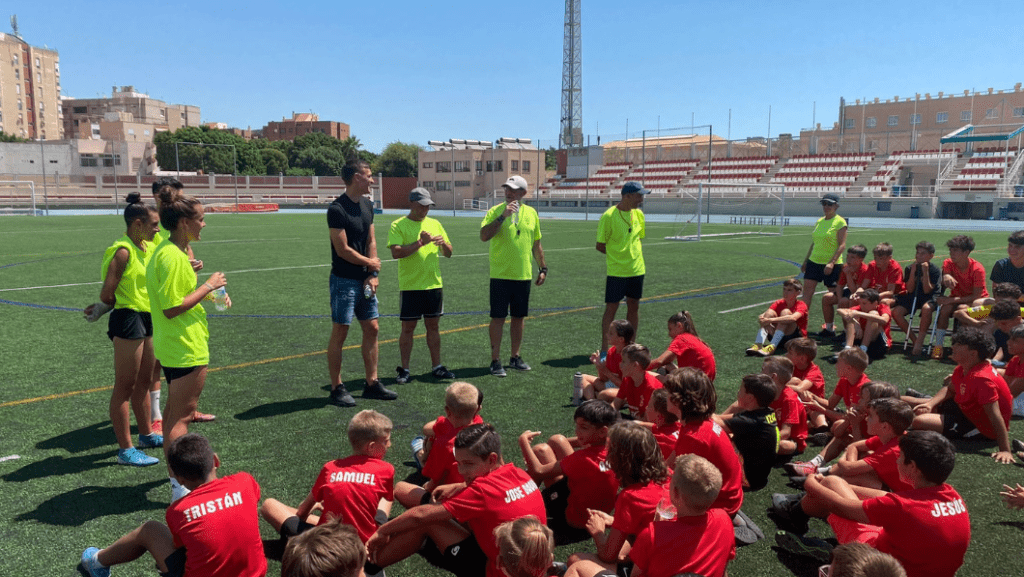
left=558, top=443, right=618, bottom=528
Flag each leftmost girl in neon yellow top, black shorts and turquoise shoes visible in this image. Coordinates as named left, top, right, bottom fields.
left=86, top=193, right=163, bottom=466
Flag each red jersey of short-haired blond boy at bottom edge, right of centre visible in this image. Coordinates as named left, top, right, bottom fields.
left=630, top=509, right=736, bottom=577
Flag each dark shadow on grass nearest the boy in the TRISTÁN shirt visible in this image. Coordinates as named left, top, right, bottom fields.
left=15, top=479, right=164, bottom=527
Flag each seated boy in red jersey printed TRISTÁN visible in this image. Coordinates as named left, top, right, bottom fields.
left=78, top=434, right=266, bottom=577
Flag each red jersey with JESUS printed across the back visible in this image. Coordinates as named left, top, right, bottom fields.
left=863, top=484, right=971, bottom=577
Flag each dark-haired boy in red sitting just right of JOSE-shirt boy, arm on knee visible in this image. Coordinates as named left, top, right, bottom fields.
left=519, top=400, right=618, bottom=545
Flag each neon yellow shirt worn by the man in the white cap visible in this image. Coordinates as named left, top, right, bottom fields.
left=480, top=202, right=541, bottom=281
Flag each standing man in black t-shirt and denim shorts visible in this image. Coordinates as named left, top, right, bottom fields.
left=327, top=161, right=398, bottom=407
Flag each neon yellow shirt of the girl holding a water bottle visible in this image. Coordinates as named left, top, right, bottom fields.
left=145, top=239, right=210, bottom=369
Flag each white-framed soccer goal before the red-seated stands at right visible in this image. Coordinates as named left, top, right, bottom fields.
left=666, top=182, right=790, bottom=241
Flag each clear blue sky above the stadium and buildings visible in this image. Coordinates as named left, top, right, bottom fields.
left=14, top=0, right=1024, bottom=152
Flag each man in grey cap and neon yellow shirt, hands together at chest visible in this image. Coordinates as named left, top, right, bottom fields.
left=387, top=188, right=455, bottom=383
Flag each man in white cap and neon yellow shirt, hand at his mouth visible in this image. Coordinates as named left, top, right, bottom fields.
left=480, top=174, right=548, bottom=377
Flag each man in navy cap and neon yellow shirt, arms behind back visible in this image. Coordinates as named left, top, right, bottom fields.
left=597, top=181, right=650, bottom=355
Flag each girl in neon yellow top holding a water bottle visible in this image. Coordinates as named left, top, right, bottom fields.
left=145, top=187, right=230, bottom=499
